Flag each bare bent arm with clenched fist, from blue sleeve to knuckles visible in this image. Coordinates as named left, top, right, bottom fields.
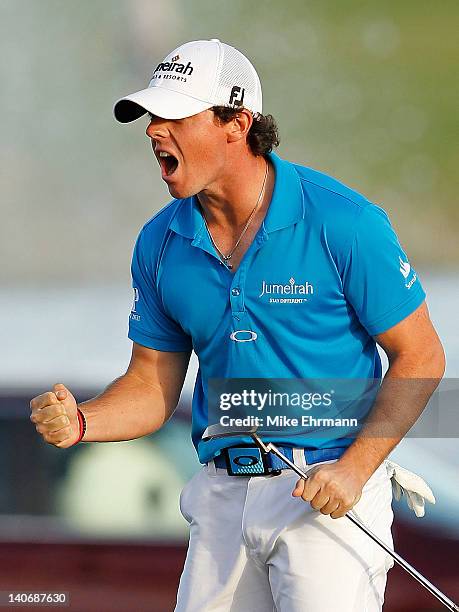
left=30, top=342, right=191, bottom=448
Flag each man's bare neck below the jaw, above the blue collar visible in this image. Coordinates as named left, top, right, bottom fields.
left=197, top=153, right=274, bottom=228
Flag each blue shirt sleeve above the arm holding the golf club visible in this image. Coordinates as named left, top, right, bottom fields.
left=343, top=204, right=425, bottom=336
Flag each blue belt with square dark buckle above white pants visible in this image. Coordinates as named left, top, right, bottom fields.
left=213, top=444, right=346, bottom=476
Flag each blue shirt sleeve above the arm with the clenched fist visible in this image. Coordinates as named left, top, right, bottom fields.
left=128, top=232, right=192, bottom=352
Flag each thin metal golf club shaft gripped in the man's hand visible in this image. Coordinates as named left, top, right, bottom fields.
left=265, top=442, right=459, bottom=612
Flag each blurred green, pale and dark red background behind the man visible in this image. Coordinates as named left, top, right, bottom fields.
left=0, top=0, right=459, bottom=612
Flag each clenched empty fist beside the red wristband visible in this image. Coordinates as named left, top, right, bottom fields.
left=30, top=384, right=80, bottom=448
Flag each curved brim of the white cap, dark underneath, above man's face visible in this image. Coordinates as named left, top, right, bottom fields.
left=113, top=86, right=213, bottom=123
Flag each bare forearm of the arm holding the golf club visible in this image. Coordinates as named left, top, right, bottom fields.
left=340, top=350, right=444, bottom=480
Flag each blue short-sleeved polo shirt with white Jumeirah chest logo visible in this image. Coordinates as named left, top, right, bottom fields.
left=129, top=154, right=425, bottom=463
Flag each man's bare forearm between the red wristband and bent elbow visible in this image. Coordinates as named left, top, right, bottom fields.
left=78, top=372, right=175, bottom=442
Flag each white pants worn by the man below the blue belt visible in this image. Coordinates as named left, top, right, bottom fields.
left=175, top=462, right=393, bottom=612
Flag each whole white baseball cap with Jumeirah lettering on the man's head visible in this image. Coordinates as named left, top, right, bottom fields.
left=113, top=38, right=262, bottom=123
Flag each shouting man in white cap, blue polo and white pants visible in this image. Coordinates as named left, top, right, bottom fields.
left=31, top=39, right=444, bottom=612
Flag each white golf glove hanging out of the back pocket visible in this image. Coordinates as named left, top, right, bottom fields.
left=385, top=459, right=435, bottom=517
